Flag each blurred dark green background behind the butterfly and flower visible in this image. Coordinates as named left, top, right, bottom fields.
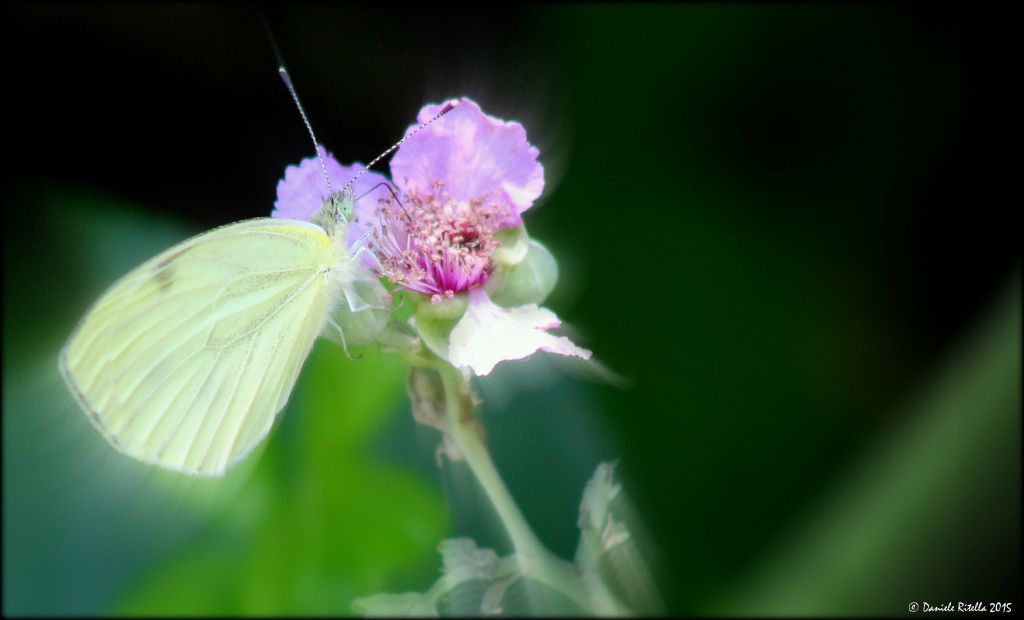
left=0, top=4, right=1021, bottom=616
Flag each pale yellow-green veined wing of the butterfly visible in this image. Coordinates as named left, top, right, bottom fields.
left=60, top=218, right=334, bottom=476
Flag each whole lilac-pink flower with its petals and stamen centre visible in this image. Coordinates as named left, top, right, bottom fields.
left=272, top=97, right=591, bottom=375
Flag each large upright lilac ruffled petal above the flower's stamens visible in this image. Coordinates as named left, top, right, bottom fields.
left=391, top=97, right=544, bottom=223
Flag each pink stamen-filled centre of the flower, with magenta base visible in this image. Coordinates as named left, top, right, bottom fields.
left=368, top=180, right=508, bottom=302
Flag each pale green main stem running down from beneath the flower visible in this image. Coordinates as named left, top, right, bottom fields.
left=440, top=367, right=629, bottom=615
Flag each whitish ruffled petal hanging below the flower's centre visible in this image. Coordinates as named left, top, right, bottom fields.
left=449, top=289, right=591, bottom=375
